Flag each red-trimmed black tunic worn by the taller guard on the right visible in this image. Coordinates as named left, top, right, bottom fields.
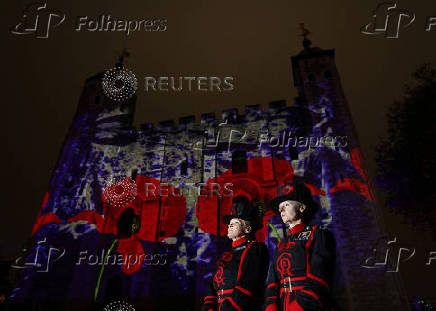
left=264, top=224, right=335, bottom=311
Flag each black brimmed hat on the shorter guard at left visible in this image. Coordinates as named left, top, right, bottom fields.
left=223, top=196, right=262, bottom=232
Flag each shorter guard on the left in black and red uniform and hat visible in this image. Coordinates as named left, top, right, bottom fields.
left=202, top=197, right=269, bottom=311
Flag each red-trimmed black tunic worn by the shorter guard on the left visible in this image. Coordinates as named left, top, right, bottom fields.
left=202, top=237, right=269, bottom=311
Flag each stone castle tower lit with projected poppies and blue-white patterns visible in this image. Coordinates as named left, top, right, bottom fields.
left=13, top=39, right=408, bottom=310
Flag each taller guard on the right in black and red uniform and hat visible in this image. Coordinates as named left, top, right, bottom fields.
left=264, top=184, right=335, bottom=311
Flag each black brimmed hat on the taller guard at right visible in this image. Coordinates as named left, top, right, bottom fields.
left=270, top=183, right=318, bottom=214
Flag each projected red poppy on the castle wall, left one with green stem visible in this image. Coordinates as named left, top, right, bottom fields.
left=68, top=175, right=186, bottom=274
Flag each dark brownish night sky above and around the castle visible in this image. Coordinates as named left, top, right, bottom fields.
left=0, top=0, right=436, bottom=302
